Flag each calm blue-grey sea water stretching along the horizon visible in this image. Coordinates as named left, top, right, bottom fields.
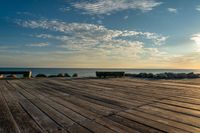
left=0, top=68, right=200, bottom=77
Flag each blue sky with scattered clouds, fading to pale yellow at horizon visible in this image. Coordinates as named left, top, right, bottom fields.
left=0, top=0, right=200, bottom=69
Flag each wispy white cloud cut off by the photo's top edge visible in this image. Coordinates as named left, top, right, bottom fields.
left=73, top=0, right=162, bottom=15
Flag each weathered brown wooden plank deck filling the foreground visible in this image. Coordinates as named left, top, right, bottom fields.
left=0, top=78, right=200, bottom=133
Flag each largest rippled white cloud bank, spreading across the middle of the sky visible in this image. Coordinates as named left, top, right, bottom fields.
left=17, top=20, right=167, bottom=60
